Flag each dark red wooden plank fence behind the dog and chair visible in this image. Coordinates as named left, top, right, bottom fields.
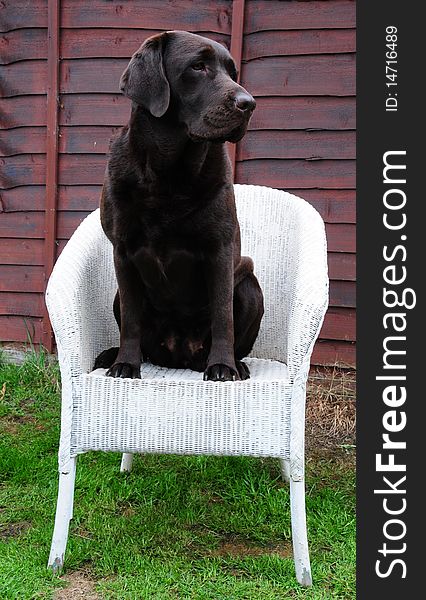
left=0, top=0, right=356, bottom=366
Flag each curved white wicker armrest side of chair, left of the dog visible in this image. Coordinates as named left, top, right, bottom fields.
left=46, top=209, right=118, bottom=377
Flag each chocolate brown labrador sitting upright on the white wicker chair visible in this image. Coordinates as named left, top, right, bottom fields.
left=94, top=31, right=263, bottom=381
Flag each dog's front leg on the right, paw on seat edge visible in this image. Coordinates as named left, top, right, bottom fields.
left=204, top=245, right=240, bottom=381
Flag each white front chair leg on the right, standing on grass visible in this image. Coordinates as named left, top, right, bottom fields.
left=290, top=478, right=312, bottom=587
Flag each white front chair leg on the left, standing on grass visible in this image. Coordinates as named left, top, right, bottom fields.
left=47, top=458, right=77, bottom=573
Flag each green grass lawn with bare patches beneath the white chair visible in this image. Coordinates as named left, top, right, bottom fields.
left=0, top=354, right=355, bottom=600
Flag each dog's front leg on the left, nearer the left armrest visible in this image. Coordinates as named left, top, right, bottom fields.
left=107, top=246, right=142, bottom=379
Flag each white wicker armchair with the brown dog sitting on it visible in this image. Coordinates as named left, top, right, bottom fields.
left=46, top=185, right=328, bottom=586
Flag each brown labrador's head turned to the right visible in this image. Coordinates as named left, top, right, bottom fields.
left=120, top=31, right=256, bottom=142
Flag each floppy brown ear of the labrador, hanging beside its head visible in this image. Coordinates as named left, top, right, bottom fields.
left=120, top=33, right=170, bottom=117
